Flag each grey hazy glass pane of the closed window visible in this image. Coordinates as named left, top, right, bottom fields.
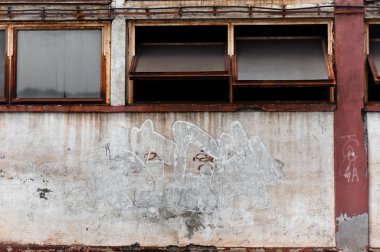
left=16, top=30, right=102, bottom=98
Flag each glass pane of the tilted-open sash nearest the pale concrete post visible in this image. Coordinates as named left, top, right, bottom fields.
left=136, top=44, right=226, bottom=72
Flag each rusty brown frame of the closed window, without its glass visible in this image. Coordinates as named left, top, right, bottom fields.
left=0, top=22, right=110, bottom=105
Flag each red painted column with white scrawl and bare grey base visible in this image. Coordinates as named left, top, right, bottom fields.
left=334, top=0, right=368, bottom=251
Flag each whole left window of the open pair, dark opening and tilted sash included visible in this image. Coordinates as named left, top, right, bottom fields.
left=129, top=26, right=230, bottom=103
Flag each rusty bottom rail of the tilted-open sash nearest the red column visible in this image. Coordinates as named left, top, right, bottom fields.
left=233, top=80, right=335, bottom=87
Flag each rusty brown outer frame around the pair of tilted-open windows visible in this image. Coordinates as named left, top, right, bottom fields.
left=126, top=19, right=336, bottom=107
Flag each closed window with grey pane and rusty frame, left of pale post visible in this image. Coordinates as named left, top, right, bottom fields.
left=0, top=24, right=109, bottom=104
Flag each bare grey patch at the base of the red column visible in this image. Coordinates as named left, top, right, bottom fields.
left=336, top=214, right=368, bottom=252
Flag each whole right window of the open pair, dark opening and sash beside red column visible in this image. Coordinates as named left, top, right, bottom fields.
left=232, top=25, right=335, bottom=102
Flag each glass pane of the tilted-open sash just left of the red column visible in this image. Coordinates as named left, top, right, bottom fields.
left=236, top=39, right=328, bottom=80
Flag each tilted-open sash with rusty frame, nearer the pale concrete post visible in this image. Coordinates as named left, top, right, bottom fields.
left=130, top=43, right=229, bottom=80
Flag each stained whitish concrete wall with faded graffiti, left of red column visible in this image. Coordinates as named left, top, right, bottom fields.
left=0, top=112, right=332, bottom=247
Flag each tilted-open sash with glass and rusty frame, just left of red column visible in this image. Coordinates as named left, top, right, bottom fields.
left=234, top=37, right=335, bottom=87
